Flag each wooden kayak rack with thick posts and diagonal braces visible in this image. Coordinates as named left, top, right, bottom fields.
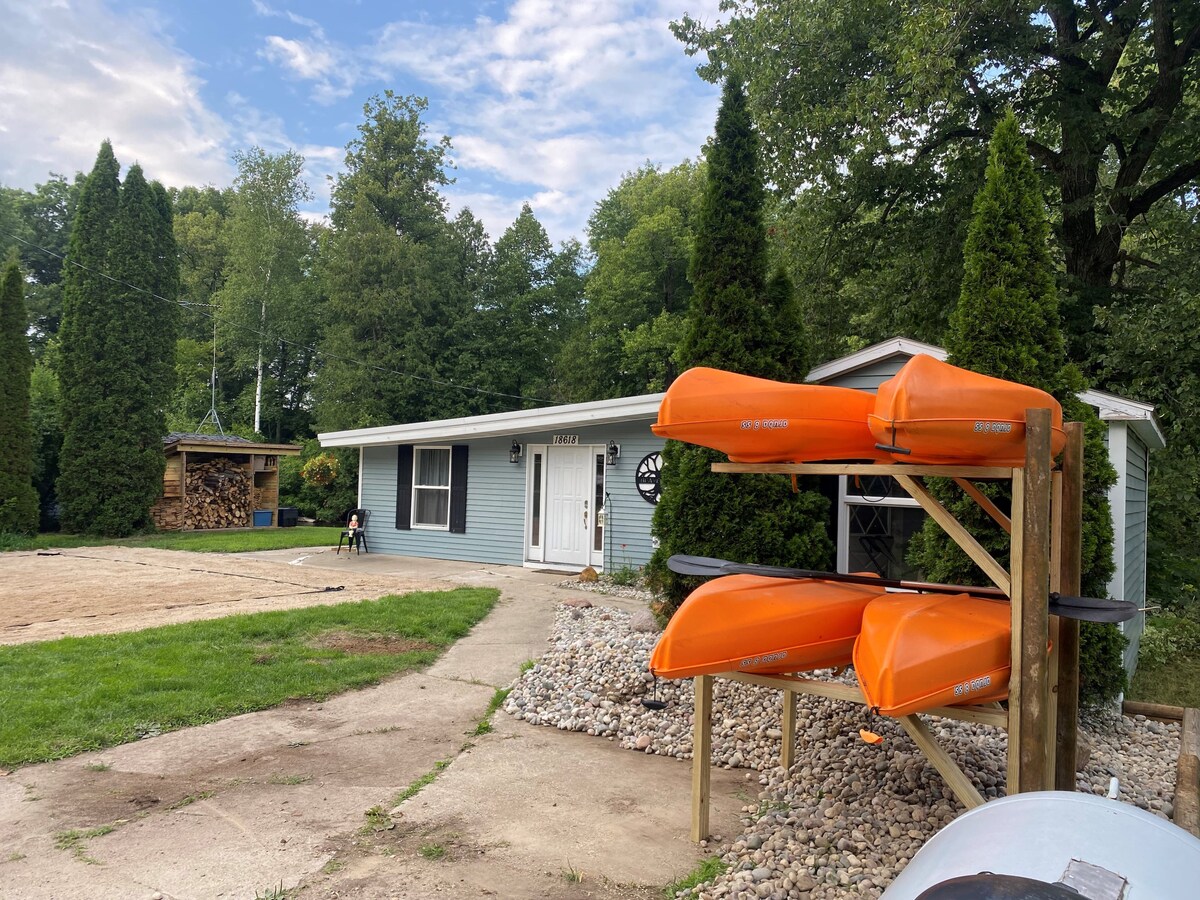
left=691, top=409, right=1084, bottom=841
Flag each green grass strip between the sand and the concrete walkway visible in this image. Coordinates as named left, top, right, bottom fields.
left=0, top=588, right=499, bottom=767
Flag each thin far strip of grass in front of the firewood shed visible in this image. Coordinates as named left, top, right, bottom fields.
left=0, top=527, right=342, bottom=553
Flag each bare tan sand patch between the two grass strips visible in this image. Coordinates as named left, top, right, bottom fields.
left=0, top=547, right=449, bottom=644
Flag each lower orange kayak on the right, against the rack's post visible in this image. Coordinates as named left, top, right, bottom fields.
left=853, top=594, right=1013, bottom=716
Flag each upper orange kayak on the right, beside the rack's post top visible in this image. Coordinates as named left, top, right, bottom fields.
left=868, top=353, right=1067, bottom=466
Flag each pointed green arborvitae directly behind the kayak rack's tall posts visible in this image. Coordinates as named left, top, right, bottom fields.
left=910, top=110, right=1123, bottom=702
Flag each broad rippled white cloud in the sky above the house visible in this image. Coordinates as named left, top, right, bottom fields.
left=367, top=0, right=719, bottom=240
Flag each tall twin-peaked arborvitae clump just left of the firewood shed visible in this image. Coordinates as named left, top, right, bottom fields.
left=58, top=150, right=178, bottom=536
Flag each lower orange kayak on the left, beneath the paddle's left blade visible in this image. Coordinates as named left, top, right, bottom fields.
left=650, top=575, right=884, bottom=678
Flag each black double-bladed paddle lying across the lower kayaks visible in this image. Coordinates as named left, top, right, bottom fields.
left=667, top=553, right=1138, bottom=623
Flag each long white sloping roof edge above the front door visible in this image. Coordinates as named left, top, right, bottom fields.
left=317, top=394, right=665, bottom=446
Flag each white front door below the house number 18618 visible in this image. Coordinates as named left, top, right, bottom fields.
left=545, top=446, right=595, bottom=568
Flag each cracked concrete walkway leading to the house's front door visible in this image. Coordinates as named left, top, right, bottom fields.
left=0, top=551, right=757, bottom=900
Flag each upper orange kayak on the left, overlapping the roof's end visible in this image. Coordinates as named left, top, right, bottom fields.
left=650, top=367, right=890, bottom=462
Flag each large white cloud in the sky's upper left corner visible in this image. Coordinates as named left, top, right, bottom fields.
left=0, top=0, right=232, bottom=187
